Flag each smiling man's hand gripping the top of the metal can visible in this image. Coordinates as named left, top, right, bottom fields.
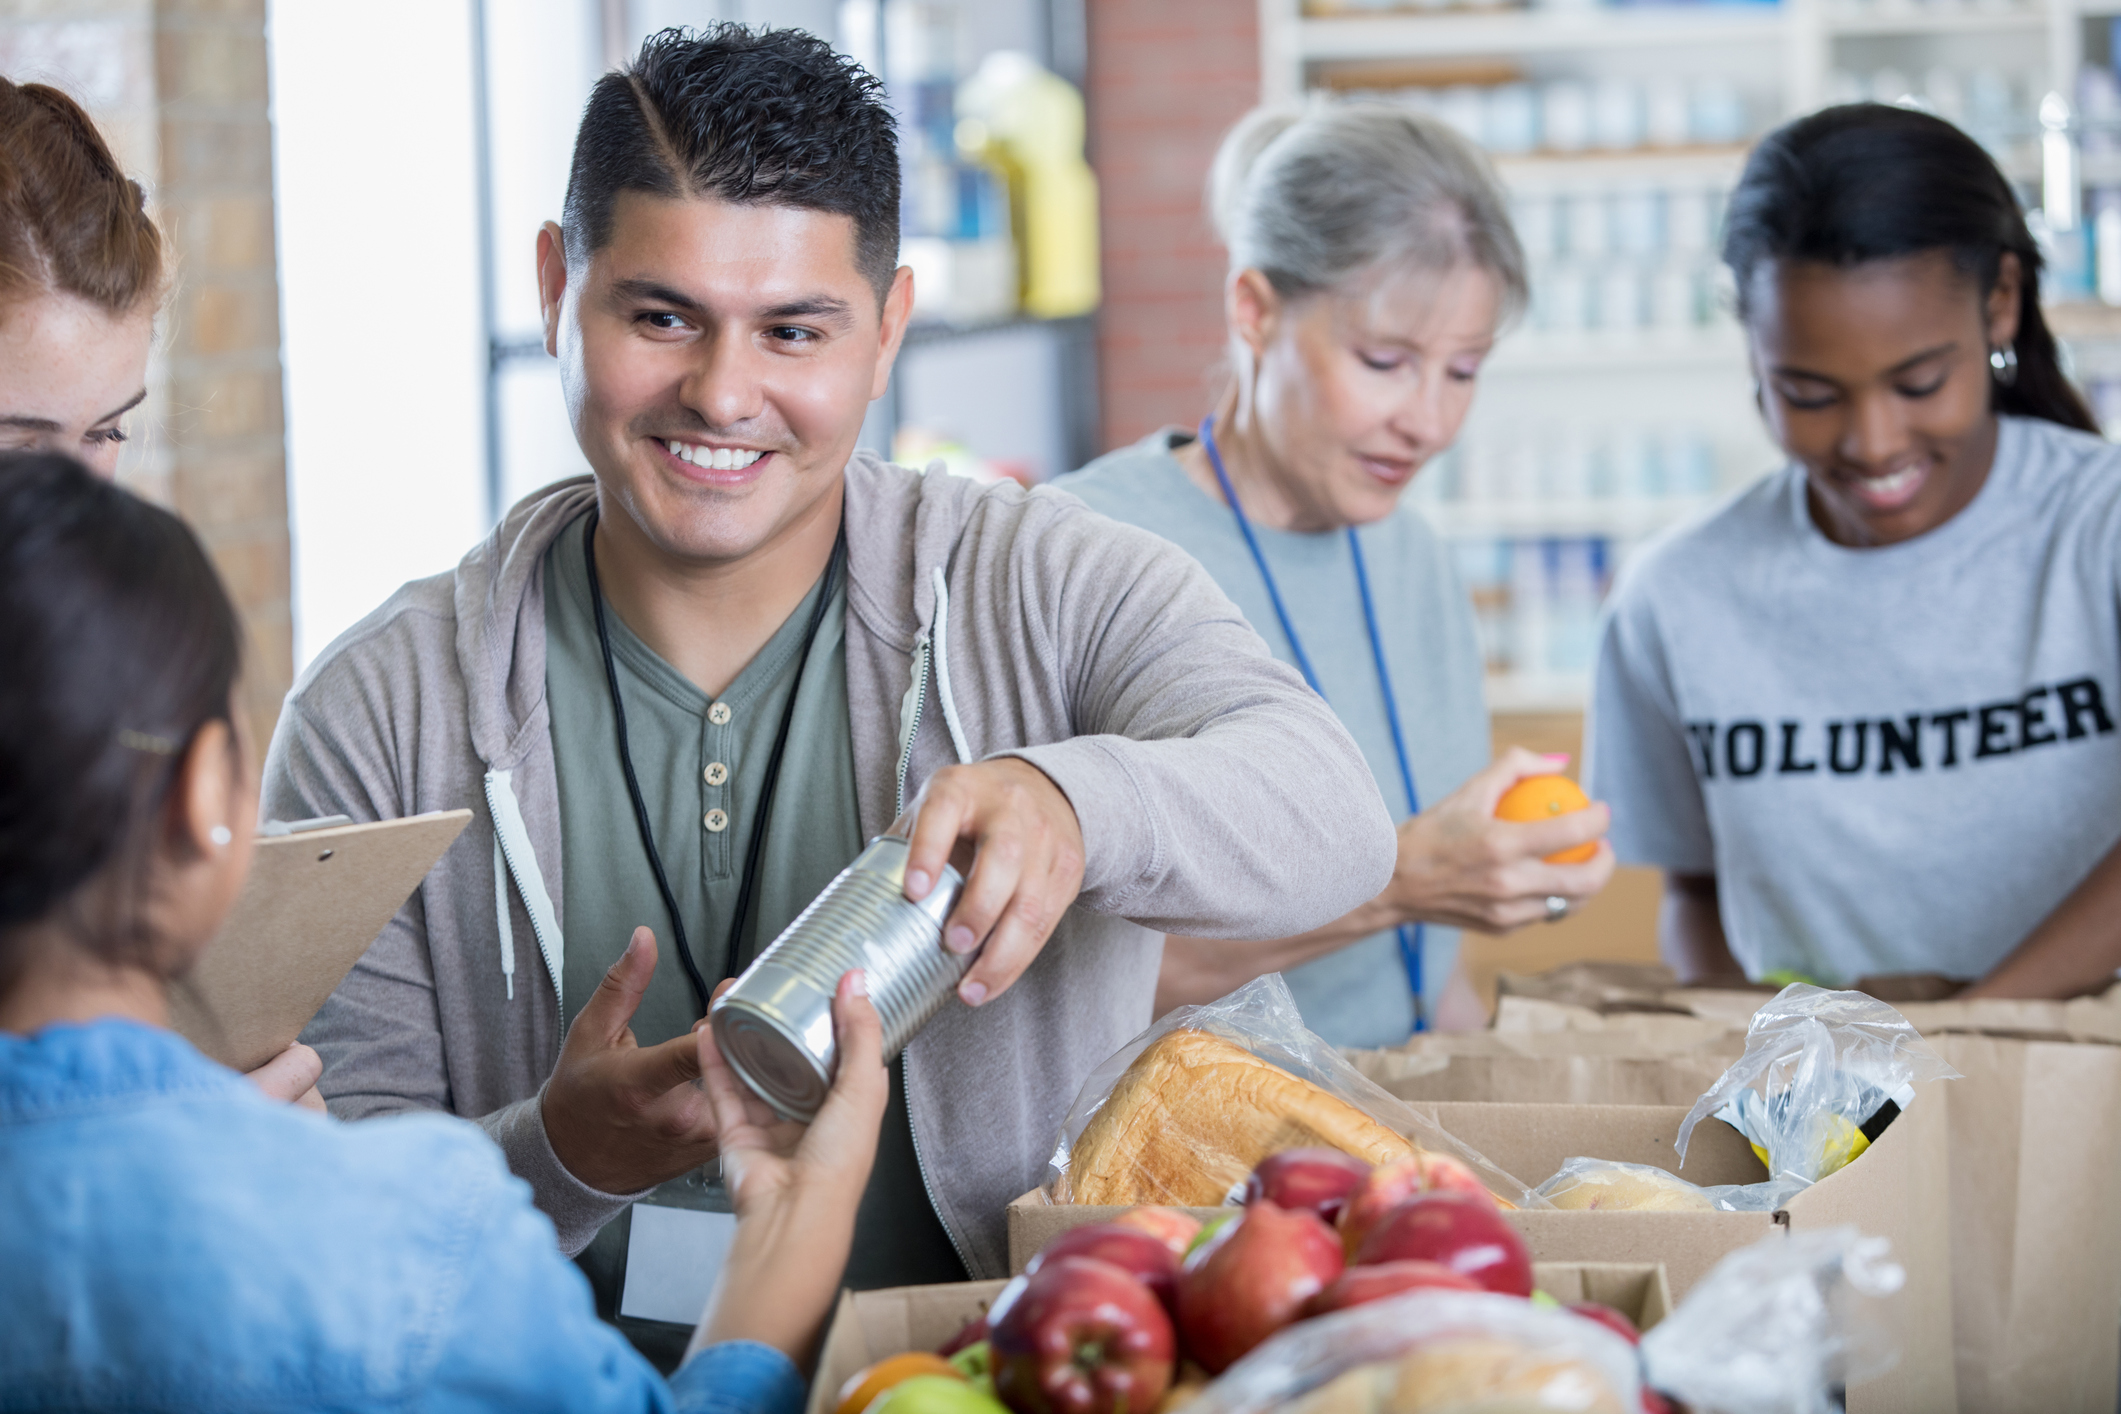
left=906, top=757, right=1084, bottom=1007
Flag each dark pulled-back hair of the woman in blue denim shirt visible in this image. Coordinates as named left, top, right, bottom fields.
left=0, top=454, right=242, bottom=988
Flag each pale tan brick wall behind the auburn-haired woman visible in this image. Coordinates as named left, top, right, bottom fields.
left=0, top=0, right=293, bottom=753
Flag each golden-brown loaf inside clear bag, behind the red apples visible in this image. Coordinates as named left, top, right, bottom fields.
left=1067, top=1030, right=1415, bottom=1208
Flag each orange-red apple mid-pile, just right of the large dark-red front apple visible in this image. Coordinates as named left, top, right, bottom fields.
left=1177, top=1200, right=1345, bottom=1374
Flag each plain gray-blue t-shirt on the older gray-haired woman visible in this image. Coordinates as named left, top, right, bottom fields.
left=1054, top=428, right=1489, bottom=1045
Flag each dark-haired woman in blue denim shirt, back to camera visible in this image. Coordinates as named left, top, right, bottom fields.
left=0, top=454, right=887, bottom=1414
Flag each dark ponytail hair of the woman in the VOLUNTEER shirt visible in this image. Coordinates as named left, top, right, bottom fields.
left=1722, top=104, right=2100, bottom=432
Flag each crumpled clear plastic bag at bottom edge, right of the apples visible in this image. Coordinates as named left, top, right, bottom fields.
left=1642, top=1227, right=1907, bottom=1414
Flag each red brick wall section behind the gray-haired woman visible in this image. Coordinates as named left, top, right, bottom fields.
left=1086, top=0, right=1260, bottom=449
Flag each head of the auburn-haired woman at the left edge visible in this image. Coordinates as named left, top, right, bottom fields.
left=0, top=78, right=168, bottom=477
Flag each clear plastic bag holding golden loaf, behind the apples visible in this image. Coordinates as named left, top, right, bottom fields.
left=1046, top=973, right=1546, bottom=1208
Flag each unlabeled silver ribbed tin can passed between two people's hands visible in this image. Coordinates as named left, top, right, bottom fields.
left=711, top=835, right=971, bottom=1121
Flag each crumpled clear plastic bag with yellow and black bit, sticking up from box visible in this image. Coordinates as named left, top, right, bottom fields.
left=1678, top=982, right=1960, bottom=1183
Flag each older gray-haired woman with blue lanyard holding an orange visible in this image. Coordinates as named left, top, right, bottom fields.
left=1061, top=102, right=1614, bottom=1045
